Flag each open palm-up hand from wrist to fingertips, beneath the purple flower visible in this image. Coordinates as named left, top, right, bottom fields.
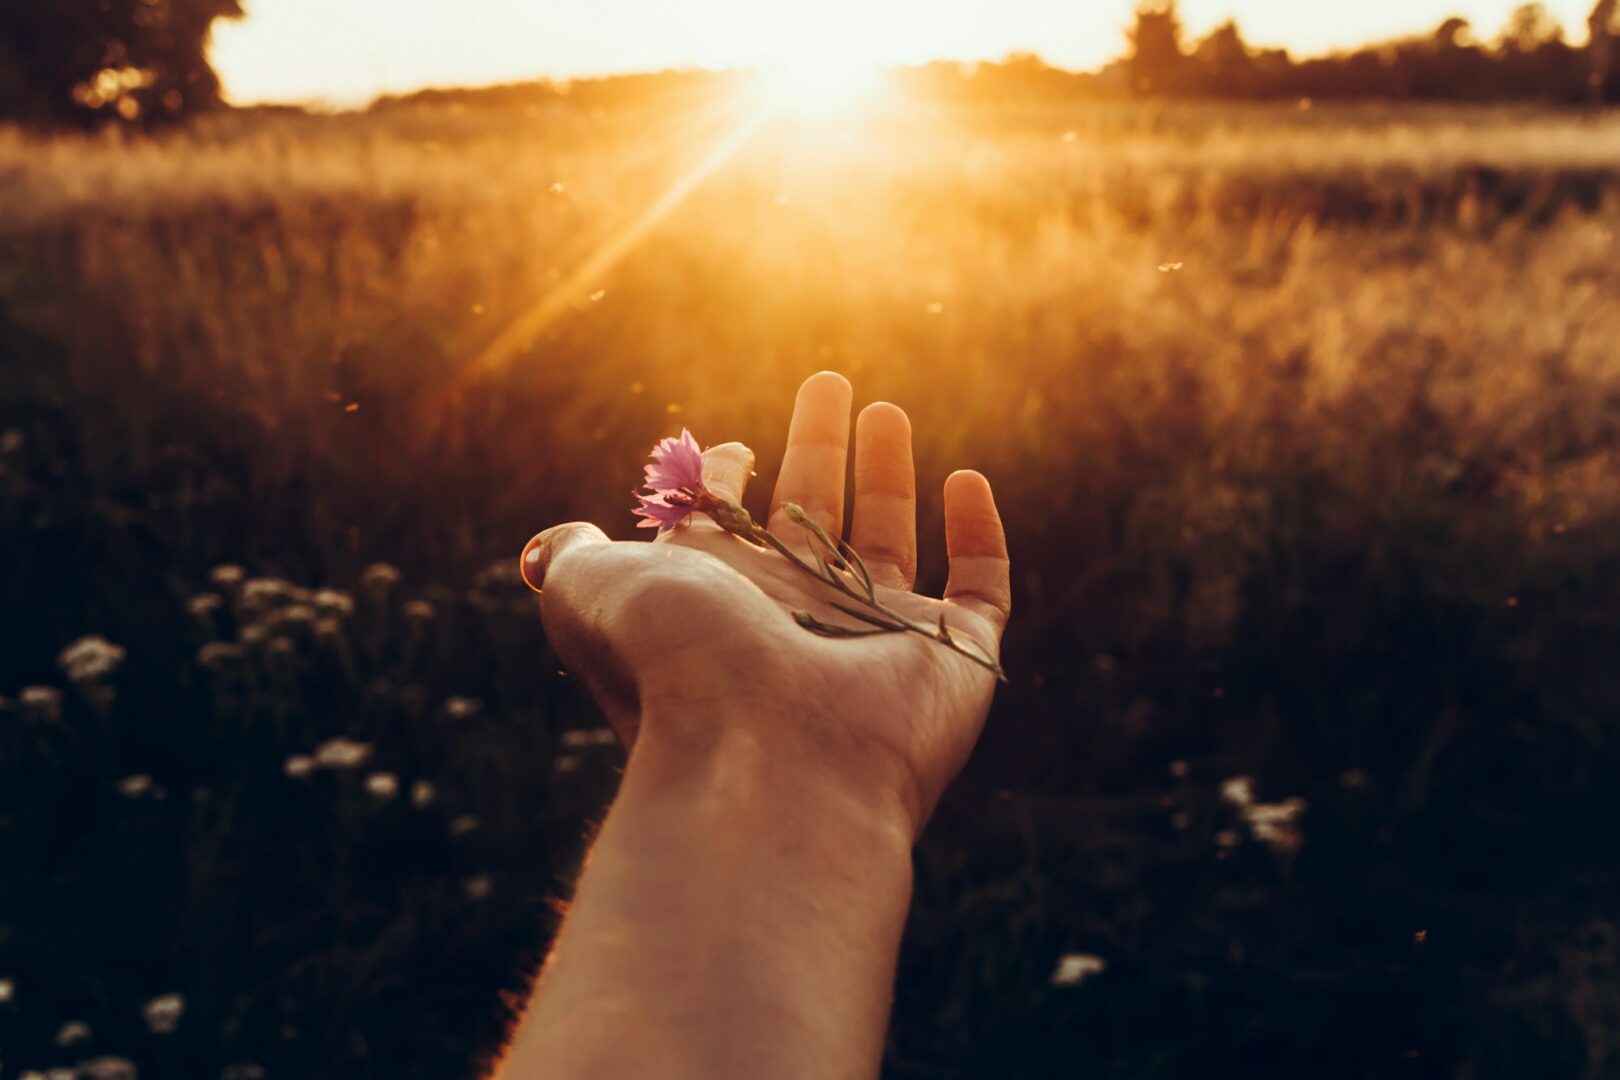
left=522, top=372, right=1011, bottom=837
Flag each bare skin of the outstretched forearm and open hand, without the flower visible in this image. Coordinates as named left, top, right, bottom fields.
left=496, top=372, right=1011, bottom=1080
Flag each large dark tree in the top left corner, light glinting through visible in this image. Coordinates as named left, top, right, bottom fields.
left=0, top=0, right=241, bottom=126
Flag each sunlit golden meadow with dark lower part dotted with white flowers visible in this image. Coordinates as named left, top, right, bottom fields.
left=0, top=88, right=1620, bottom=1080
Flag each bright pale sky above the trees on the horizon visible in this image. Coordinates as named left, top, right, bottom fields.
left=214, top=0, right=1591, bottom=104
